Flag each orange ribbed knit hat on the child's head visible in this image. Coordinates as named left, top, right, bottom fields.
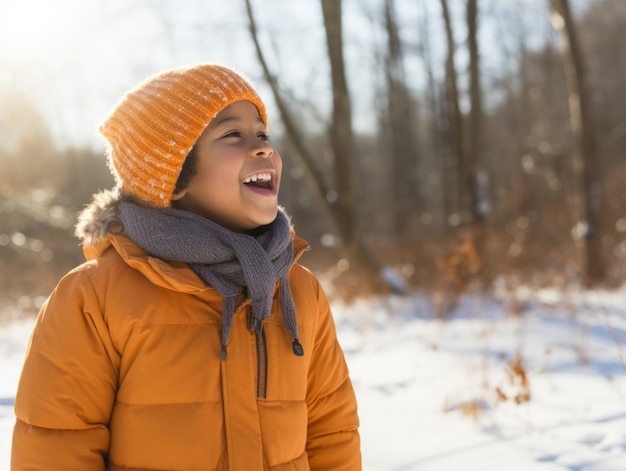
left=100, top=64, right=267, bottom=207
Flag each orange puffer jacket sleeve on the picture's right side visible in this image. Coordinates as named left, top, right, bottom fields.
left=307, top=276, right=361, bottom=471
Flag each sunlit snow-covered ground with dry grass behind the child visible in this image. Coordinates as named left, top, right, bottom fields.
left=0, top=290, right=626, bottom=471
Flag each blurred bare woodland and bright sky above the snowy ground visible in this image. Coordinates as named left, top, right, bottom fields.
left=0, top=0, right=626, bottom=314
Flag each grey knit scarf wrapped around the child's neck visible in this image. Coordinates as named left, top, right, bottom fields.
left=118, top=201, right=303, bottom=360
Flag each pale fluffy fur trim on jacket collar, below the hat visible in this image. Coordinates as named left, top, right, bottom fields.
left=74, top=190, right=120, bottom=247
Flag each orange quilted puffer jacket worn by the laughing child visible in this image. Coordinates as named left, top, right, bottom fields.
left=11, top=201, right=361, bottom=471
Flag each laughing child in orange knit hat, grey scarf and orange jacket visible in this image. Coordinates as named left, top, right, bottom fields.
left=11, top=64, right=361, bottom=471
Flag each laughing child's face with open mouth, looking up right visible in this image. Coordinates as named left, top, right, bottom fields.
left=172, top=101, right=282, bottom=232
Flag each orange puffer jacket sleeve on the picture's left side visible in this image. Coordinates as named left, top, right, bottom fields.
left=11, top=270, right=118, bottom=471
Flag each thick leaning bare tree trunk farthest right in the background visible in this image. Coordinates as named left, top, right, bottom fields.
left=550, top=0, right=605, bottom=286
